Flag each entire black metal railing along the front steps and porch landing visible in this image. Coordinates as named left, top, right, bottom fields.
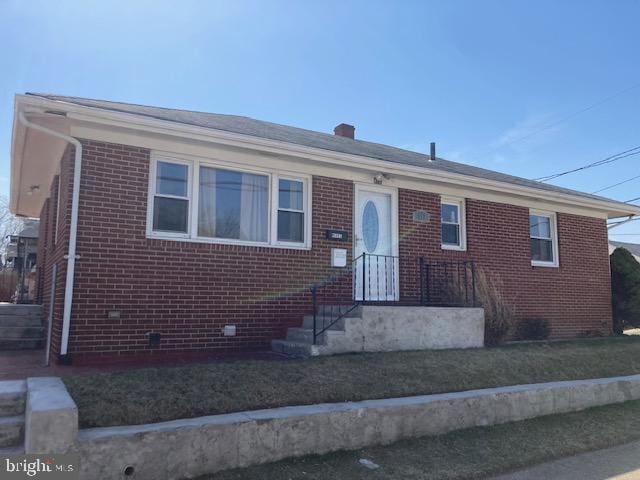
left=310, top=253, right=477, bottom=345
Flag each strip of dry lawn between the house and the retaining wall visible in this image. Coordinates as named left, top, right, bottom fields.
left=64, top=336, right=640, bottom=428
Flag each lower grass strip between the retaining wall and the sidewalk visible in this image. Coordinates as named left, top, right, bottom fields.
left=200, top=400, right=640, bottom=480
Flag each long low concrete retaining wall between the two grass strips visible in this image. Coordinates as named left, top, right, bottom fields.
left=76, top=375, right=640, bottom=480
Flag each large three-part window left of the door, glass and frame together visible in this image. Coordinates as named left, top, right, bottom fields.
left=148, top=158, right=311, bottom=248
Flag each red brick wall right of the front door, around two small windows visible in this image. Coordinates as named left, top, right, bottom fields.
left=398, top=190, right=611, bottom=338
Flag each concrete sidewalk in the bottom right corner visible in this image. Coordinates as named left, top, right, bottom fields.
left=493, top=442, right=640, bottom=480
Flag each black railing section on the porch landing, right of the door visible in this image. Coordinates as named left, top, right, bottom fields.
left=419, top=257, right=477, bottom=307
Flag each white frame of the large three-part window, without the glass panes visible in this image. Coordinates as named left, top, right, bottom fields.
left=147, top=152, right=312, bottom=250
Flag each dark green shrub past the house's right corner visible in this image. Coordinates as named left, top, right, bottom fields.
left=610, top=247, right=640, bottom=334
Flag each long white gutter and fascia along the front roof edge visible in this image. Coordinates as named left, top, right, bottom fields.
left=16, top=95, right=640, bottom=218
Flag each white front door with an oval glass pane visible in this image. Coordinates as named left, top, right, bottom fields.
left=353, top=185, right=399, bottom=301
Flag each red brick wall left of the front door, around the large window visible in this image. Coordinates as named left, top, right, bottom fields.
left=63, top=142, right=353, bottom=360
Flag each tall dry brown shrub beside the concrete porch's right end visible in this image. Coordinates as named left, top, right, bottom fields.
left=476, top=268, right=515, bottom=347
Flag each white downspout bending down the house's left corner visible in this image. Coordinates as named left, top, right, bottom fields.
left=18, top=110, right=82, bottom=355
